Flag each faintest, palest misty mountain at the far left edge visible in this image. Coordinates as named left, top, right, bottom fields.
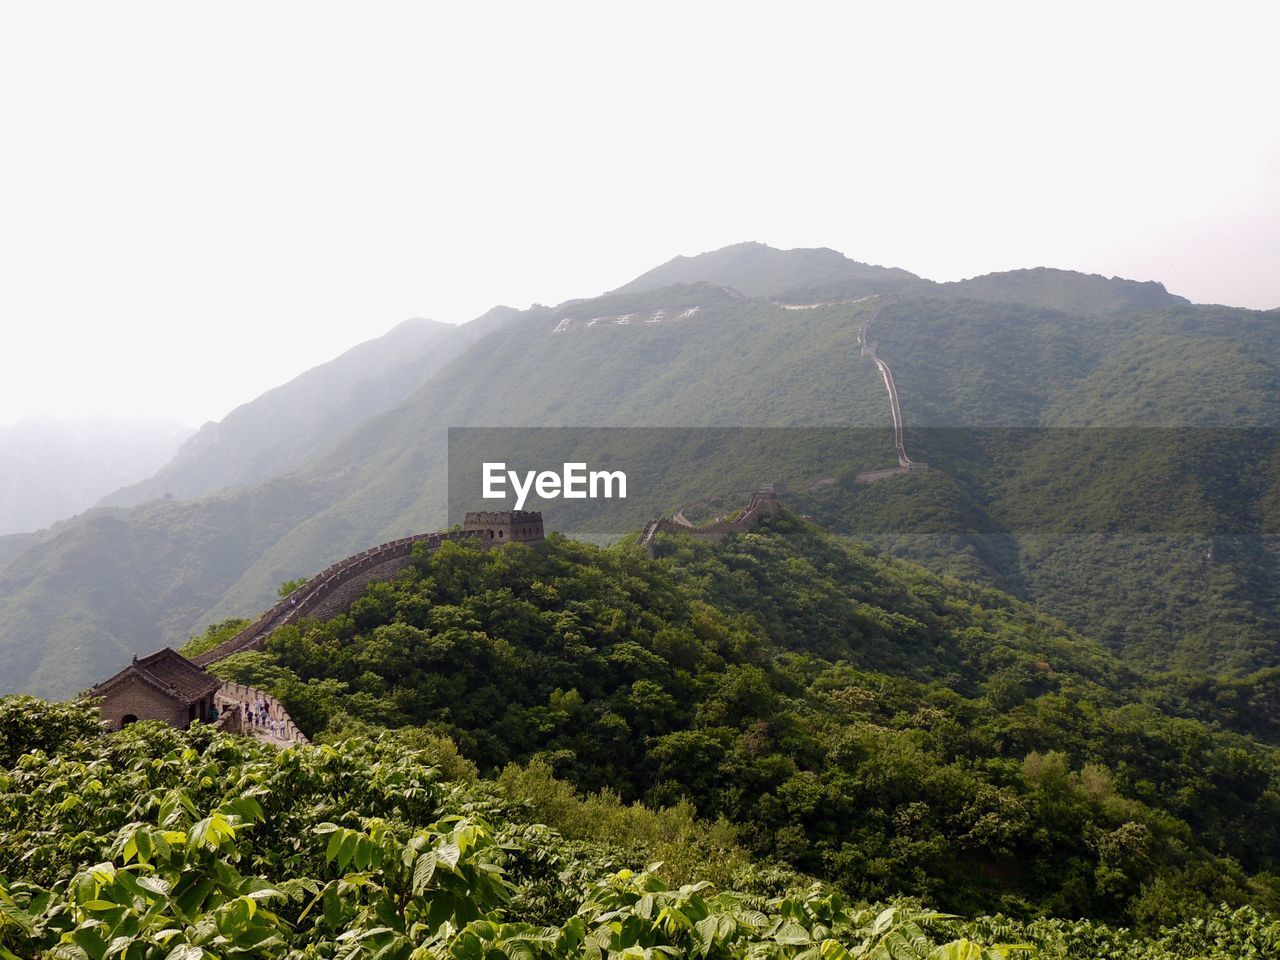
left=0, top=417, right=191, bottom=537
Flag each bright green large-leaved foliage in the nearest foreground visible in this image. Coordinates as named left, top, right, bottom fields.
left=0, top=700, right=1049, bottom=960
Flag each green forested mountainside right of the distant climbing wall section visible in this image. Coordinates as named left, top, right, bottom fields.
left=805, top=300, right=1280, bottom=672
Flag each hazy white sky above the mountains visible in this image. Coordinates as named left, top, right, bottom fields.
left=0, top=0, right=1280, bottom=424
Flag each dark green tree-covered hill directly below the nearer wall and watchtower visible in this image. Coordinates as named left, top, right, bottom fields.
left=204, top=516, right=1280, bottom=929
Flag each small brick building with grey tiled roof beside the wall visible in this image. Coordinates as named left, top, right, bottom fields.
left=90, top=646, right=223, bottom=730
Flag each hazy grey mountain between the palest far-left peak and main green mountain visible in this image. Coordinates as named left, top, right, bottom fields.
left=101, top=316, right=504, bottom=507
